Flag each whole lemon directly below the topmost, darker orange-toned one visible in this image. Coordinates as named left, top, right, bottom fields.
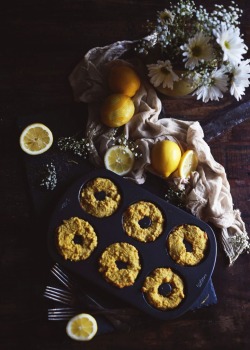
left=101, top=94, right=135, bottom=128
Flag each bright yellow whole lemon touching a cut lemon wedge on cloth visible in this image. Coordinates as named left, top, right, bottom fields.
left=151, top=140, right=181, bottom=177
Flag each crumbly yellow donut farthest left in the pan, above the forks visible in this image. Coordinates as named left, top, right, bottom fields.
left=57, top=217, right=97, bottom=261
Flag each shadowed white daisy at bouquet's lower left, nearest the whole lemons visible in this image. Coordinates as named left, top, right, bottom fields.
left=147, top=60, right=179, bottom=89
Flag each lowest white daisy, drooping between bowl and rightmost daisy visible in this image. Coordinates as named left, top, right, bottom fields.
left=194, top=67, right=228, bottom=102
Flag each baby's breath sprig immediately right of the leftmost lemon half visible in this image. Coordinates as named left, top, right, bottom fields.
left=57, top=136, right=93, bottom=159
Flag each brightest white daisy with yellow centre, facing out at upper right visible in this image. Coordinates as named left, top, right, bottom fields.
left=213, top=23, right=247, bottom=64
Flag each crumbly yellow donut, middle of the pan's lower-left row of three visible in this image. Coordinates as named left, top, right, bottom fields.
left=99, top=242, right=141, bottom=288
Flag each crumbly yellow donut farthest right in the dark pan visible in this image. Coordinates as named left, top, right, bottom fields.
left=168, top=224, right=208, bottom=266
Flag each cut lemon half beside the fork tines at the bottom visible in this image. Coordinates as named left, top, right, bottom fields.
left=66, top=314, right=98, bottom=341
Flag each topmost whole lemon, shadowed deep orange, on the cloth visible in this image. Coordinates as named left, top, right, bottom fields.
left=108, top=65, right=141, bottom=97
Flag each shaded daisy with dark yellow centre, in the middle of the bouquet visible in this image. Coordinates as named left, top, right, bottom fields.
left=180, top=32, right=213, bottom=69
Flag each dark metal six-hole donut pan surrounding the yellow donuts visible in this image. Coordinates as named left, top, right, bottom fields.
left=48, top=169, right=217, bottom=320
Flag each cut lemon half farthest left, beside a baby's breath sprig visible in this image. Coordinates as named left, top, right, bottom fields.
left=19, top=123, right=53, bottom=155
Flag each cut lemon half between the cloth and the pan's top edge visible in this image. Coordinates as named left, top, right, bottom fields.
left=104, top=146, right=134, bottom=176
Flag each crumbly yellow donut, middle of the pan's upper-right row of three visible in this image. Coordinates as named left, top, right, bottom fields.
left=123, top=201, right=164, bottom=242
